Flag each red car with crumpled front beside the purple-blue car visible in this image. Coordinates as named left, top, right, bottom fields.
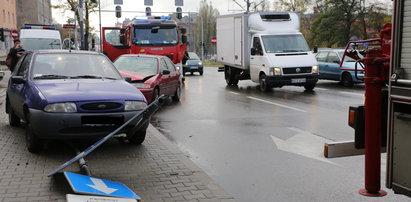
left=114, top=54, right=181, bottom=102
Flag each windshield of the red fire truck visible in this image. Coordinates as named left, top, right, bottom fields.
left=133, top=28, right=178, bottom=46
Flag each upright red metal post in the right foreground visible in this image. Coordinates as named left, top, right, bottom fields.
left=359, top=24, right=391, bottom=196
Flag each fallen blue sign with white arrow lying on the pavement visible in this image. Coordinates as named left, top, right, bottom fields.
left=64, top=172, right=141, bottom=200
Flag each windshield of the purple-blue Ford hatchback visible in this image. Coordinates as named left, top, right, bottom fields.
left=31, top=53, right=122, bottom=79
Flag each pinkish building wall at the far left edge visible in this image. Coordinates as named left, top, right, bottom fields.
left=0, top=0, right=17, bottom=60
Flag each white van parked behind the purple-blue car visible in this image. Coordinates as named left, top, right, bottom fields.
left=19, top=25, right=62, bottom=50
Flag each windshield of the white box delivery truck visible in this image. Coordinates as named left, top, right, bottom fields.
left=262, top=34, right=310, bottom=53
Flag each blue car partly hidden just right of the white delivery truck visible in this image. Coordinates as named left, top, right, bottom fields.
left=315, top=49, right=364, bottom=87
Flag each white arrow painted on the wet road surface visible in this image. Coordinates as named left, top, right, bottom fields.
left=271, top=127, right=338, bottom=165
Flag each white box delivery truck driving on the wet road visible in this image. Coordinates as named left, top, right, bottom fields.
left=217, top=12, right=318, bottom=91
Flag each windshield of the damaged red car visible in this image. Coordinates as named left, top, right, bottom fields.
left=114, top=56, right=158, bottom=75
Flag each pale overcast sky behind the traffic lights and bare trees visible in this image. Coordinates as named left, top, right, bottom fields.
left=51, top=0, right=245, bottom=29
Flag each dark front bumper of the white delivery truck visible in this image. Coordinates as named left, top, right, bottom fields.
left=266, top=74, right=318, bottom=87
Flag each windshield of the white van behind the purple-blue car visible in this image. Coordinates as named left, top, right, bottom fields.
left=20, top=38, right=61, bottom=50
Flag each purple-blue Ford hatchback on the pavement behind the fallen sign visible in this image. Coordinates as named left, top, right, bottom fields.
left=6, top=50, right=149, bottom=152
